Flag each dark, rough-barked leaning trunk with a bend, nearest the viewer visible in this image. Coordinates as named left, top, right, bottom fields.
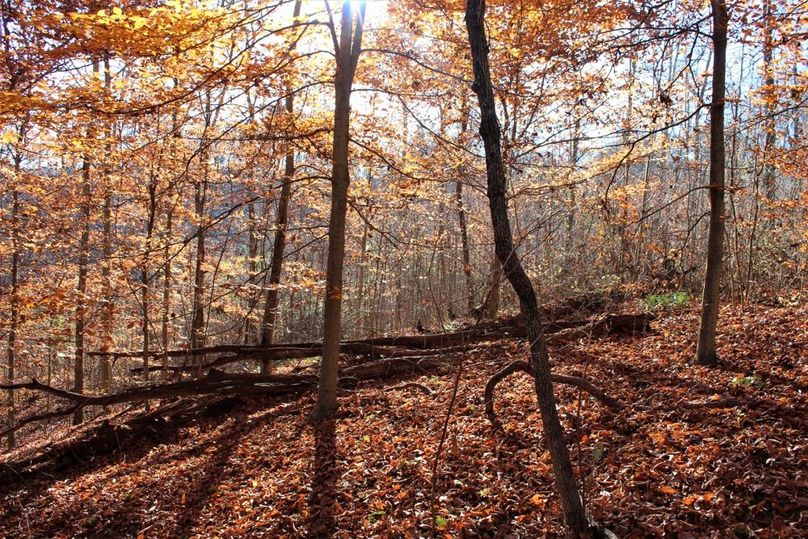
left=466, top=0, right=591, bottom=537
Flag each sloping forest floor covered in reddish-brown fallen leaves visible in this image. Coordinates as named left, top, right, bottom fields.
left=0, top=305, right=808, bottom=539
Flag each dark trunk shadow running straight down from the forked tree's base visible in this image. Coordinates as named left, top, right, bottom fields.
left=306, top=419, right=339, bottom=537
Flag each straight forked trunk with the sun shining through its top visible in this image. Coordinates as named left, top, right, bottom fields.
left=312, top=1, right=365, bottom=420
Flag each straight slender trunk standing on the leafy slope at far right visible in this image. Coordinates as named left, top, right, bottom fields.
left=696, top=0, right=729, bottom=365
